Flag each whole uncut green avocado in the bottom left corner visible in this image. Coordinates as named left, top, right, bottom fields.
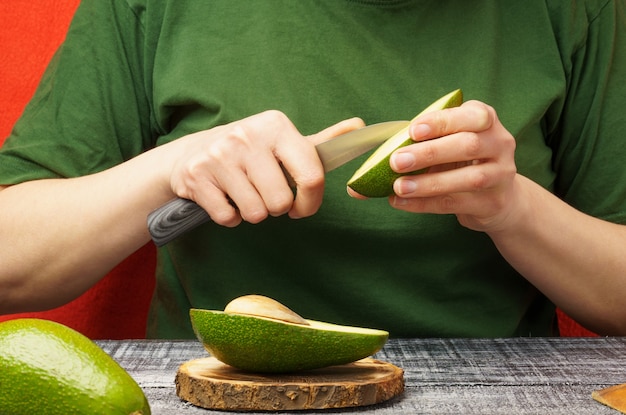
left=0, top=319, right=150, bottom=415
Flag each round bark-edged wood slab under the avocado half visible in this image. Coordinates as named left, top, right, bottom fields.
left=176, top=357, right=404, bottom=411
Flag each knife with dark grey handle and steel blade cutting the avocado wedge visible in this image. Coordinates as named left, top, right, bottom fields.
left=148, top=121, right=409, bottom=246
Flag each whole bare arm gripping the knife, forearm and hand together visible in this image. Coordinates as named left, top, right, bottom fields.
left=0, top=111, right=363, bottom=313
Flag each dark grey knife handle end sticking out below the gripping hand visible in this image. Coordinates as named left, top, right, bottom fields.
left=148, top=198, right=211, bottom=246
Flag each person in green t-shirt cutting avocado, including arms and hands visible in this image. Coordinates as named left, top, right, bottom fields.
left=0, top=0, right=626, bottom=337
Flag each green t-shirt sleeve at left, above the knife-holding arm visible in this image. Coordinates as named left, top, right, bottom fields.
left=0, top=0, right=153, bottom=184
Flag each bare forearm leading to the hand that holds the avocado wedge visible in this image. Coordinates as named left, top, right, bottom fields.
left=489, top=176, right=626, bottom=334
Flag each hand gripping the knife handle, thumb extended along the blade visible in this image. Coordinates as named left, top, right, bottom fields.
left=167, top=111, right=363, bottom=227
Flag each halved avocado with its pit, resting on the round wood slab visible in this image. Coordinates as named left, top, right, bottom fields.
left=190, top=295, right=389, bottom=373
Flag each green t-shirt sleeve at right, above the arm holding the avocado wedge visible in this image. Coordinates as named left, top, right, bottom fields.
left=550, top=1, right=626, bottom=223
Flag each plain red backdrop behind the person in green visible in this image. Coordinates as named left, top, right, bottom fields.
left=0, top=0, right=595, bottom=339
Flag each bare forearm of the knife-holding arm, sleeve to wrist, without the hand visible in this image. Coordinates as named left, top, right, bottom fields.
left=0, top=146, right=173, bottom=313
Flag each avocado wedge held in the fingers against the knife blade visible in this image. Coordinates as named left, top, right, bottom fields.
left=348, top=89, right=463, bottom=197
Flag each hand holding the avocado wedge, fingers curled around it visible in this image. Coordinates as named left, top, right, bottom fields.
left=378, top=101, right=518, bottom=231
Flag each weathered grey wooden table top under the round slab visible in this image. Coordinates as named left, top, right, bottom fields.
left=97, top=338, right=626, bottom=415
